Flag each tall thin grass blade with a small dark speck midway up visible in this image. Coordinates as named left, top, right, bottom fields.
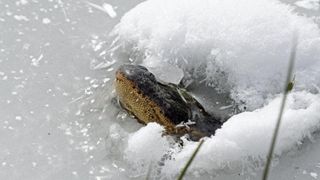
left=262, top=33, right=298, bottom=180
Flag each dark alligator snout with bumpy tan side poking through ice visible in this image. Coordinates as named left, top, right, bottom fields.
left=115, top=65, right=221, bottom=140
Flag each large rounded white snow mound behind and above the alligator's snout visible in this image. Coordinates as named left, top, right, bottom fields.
left=113, top=0, right=320, bottom=109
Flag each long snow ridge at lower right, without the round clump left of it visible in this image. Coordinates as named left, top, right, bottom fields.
left=164, top=92, right=320, bottom=176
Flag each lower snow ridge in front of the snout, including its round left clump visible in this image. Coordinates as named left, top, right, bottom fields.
left=105, top=91, right=320, bottom=178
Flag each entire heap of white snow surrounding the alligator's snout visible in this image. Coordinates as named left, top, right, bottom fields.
left=107, top=0, right=320, bottom=177
